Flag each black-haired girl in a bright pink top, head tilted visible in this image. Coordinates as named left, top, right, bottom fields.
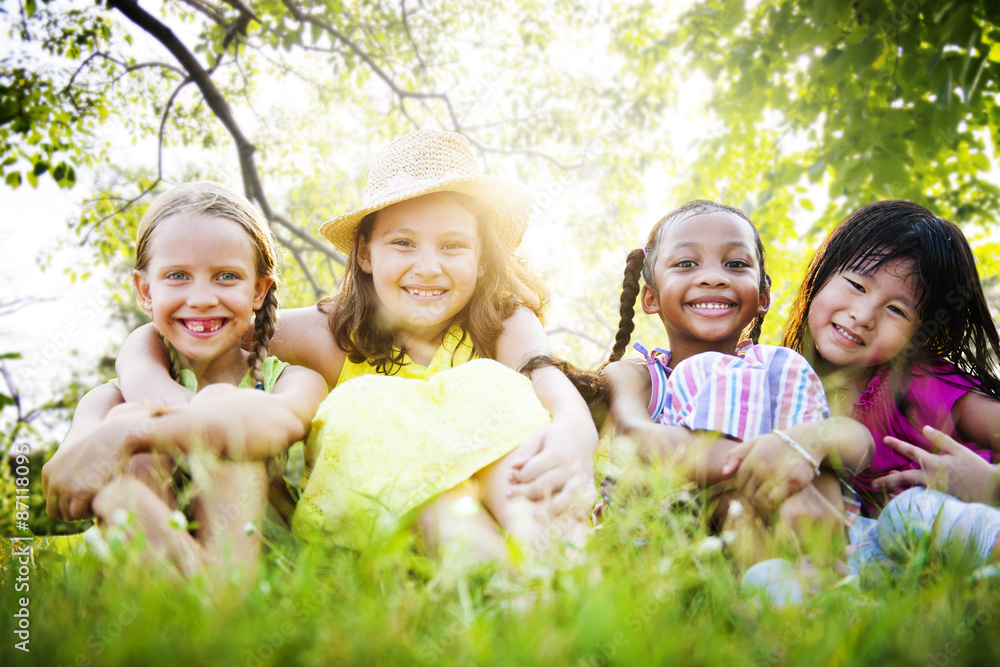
left=784, top=201, right=1000, bottom=560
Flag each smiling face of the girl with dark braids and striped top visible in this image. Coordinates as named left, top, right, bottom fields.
left=642, top=211, right=770, bottom=365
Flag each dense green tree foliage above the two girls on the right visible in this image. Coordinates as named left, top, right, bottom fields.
left=644, top=0, right=1000, bottom=336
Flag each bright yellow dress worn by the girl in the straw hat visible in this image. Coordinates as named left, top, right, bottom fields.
left=292, top=326, right=550, bottom=546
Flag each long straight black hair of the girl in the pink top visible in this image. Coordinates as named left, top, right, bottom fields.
left=782, top=201, right=1000, bottom=400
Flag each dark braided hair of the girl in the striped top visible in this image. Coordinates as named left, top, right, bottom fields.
left=608, top=199, right=771, bottom=362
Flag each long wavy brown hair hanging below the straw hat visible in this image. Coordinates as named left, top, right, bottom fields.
left=319, top=192, right=548, bottom=375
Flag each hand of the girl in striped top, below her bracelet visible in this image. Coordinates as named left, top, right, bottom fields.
left=722, top=433, right=816, bottom=516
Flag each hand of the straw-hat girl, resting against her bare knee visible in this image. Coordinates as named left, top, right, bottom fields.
left=507, top=419, right=597, bottom=514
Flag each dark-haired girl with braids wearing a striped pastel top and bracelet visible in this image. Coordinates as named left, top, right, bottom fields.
left=603, top=201, right=874, bottom=604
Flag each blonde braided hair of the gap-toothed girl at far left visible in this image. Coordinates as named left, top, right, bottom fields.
left=135, top=181, right=279, bottom=386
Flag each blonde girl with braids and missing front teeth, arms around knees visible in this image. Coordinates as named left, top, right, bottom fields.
left=42, top=182, right=326, bottom=574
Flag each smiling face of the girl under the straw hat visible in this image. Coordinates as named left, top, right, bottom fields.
left=358, top=193, right=482, bottom=347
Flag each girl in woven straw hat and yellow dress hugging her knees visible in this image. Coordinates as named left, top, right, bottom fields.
left=118, top=131, right=597, bottom=557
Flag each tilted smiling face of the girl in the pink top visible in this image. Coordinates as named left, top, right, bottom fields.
left=808, top=260, right=920, bottom=368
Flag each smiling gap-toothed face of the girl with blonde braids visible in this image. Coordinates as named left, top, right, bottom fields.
left=134, top=215, right=273, bottom=376
